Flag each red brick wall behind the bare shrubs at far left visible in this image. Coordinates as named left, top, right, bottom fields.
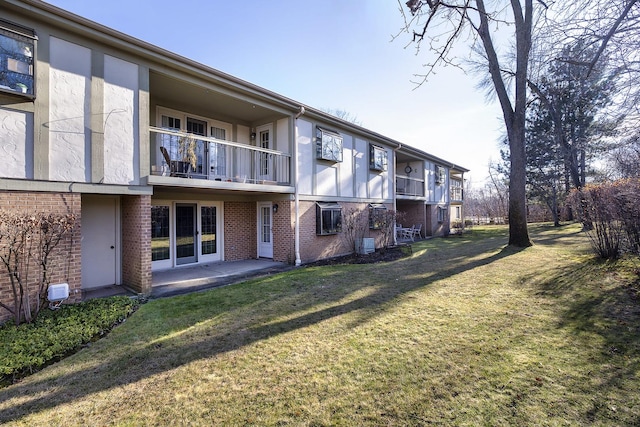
left=0, top=191, right=82, bottom=322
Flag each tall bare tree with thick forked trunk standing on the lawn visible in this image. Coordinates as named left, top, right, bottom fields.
left=401, top=0, right=545, bottom=247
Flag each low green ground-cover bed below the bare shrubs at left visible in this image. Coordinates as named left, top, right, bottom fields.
left=0, top=296, right=139, bottom=387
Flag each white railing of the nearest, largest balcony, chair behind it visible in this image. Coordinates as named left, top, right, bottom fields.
left=151, top=127, right=291, bottom=186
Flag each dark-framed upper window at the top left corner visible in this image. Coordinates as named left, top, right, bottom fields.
left=0, top=19, right=36, bottom=97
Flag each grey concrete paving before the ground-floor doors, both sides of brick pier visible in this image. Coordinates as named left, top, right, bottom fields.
left=83, top=259, right=294, bottom=300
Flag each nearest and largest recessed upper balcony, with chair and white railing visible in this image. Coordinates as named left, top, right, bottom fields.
left=148, top=69, right=293, bottom=193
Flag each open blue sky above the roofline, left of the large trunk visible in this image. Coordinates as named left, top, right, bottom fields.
left=43, top=0, right=503, bottom=186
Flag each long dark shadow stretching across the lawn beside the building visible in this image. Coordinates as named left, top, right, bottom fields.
left=0, top=231, right=518, bottom=422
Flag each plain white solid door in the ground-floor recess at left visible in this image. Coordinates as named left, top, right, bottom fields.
left=82, top=196, right=120, bottom=289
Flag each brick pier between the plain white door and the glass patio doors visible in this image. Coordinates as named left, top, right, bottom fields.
left=122, top=196, right=151, bottom=294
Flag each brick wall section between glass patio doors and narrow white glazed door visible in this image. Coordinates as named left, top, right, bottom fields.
left=224, top=202, right=256, bottom=261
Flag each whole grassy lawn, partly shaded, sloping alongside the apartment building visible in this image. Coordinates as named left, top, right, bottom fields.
left=0, top=225, right=640, bottom=426
